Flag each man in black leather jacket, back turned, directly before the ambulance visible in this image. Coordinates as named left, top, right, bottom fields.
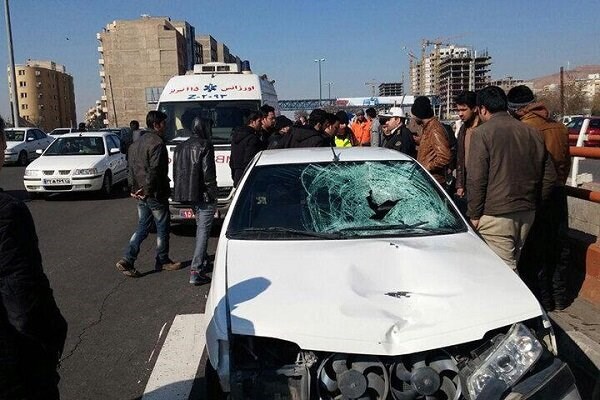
left=173, top=117, right=217, bottom=285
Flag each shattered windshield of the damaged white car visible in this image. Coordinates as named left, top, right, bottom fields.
left=227, top=161, right=467, bottom=240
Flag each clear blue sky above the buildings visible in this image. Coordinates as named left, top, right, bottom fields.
left=0, top=0, right=600, bottom=120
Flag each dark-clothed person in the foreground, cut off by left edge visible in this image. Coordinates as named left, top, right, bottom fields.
left=0, top=118, right=67, bottom=400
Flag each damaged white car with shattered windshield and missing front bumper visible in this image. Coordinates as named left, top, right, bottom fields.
left=206, top=148, right=580, bottom=400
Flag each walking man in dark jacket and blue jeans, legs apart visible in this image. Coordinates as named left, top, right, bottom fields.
left=117, top=111, right=181, bottom=278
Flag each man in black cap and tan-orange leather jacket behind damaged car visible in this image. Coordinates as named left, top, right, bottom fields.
left=410, top=96, right=452, bottom=185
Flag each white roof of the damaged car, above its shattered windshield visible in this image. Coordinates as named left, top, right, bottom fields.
left=256, top=147, right=413, bottom=165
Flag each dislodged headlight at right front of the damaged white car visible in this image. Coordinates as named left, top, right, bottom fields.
left=467, top=323, right=543, bottom=399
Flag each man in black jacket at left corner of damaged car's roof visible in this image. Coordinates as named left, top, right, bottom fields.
left=229, top=111, right=266, bottom=187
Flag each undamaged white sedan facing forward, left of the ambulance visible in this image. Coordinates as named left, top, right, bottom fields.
left=23, top=132, right=127, bottom=197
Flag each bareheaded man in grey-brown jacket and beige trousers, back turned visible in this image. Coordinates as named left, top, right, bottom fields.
left=467, top=86, right=556, bottom=272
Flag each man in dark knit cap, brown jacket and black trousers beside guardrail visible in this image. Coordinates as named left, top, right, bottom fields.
left=507, top=85, right=571, bottom=311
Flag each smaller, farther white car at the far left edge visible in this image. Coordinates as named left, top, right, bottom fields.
left=4, top=128, right=54, bottom=165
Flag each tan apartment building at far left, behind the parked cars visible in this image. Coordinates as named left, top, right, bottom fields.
left=8, top=60, right=77, bottom=132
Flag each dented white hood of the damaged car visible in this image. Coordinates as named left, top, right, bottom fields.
left=227, top=232, right=541, bottom=355
